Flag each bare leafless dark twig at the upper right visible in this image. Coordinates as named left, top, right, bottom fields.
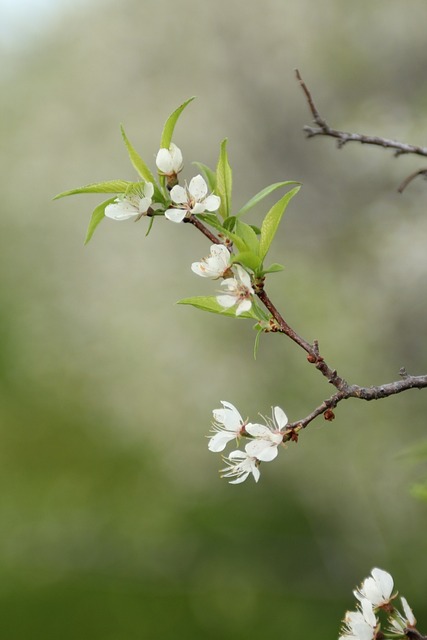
left=295, top=69, right=427, bottom=193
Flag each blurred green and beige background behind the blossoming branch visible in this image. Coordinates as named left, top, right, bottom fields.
left=0, top=0, right=427, bottom=640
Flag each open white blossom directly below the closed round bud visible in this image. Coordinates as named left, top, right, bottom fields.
left=165, top=175, right=221, bottom=222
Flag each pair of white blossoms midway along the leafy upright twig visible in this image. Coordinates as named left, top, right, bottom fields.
left=191, top=244, right=254, bottom=316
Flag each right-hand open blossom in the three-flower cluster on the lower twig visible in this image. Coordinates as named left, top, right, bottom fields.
left=245, top=407, right=288, bottom=462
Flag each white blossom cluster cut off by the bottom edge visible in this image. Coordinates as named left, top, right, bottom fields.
left=339, top=568, right=417, bottom=640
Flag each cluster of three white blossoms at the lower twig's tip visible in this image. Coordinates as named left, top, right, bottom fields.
left=208, top=400, right=288, bottom=484
